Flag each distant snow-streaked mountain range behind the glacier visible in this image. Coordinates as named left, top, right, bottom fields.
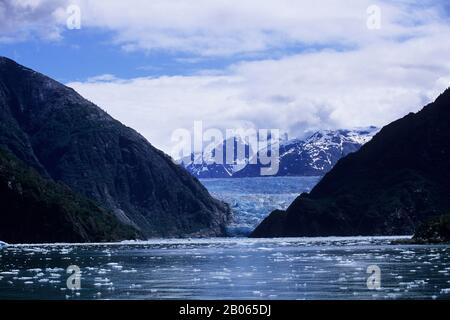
left=181, top=127, right=379, bottom=178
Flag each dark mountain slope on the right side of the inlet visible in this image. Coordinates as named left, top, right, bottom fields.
left=252, top=89, right=450, bottom=237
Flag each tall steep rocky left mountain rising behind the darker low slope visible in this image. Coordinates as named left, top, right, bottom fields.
left=0, top=58, right=230, bottom=237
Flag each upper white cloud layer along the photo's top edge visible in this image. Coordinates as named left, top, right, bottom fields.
left=0, top=0, right=447, bottom=57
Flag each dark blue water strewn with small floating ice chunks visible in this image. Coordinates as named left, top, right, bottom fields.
left=0, top=238, right=450, bottom=299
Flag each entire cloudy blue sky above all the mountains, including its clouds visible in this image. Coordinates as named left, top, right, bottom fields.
left=0, top=0, right=450, bottom=152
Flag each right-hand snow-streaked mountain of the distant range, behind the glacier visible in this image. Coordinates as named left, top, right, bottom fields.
left=234, top=127, right=379, bottom=177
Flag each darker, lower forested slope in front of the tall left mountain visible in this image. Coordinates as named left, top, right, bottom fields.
left=0, top=150, right=141, bottom=242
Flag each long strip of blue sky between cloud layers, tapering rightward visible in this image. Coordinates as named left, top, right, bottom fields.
left=0, top=21, right=356, bottom=83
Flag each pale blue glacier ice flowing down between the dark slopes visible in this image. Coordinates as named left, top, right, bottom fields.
left=201, top=177, right=320, bottom=236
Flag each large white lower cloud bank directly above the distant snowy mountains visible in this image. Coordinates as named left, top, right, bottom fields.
left=69, top=28, right=450, bottom=151
